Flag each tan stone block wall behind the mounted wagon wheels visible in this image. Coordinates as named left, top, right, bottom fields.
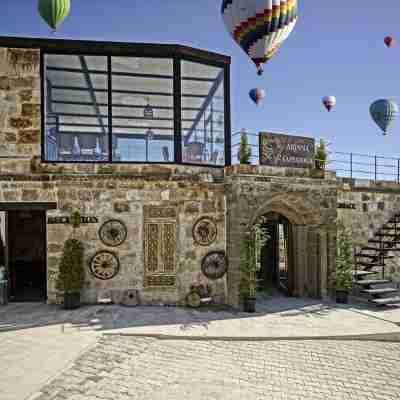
left=0, top=170, right=226, bottom=304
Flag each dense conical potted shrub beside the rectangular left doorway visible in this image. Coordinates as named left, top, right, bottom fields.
left=56, top=239, right=84, bottom=310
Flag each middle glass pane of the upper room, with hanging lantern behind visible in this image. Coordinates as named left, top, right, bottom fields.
left=111, top=57, right=174, bottom=162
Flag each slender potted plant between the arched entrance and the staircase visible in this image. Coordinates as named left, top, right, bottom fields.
left=331, top=222, right=354, bottom=304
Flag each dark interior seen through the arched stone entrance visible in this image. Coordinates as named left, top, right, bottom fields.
left=257, top=213, right=293, bottom=295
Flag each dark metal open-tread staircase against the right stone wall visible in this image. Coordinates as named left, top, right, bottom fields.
left=353, top=214, right=400, bottom=307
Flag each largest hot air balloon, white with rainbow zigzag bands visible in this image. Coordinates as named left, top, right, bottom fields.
left=221, top=0, right=297, bottom=75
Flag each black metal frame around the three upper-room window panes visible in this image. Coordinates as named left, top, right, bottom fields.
left=39, top=38, right=231, bottom=168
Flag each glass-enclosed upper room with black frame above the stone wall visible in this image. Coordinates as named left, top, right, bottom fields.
left=25, top=39, right=231, bottom=166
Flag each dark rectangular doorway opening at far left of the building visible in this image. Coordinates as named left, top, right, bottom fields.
left=7, top=210, right=47, bottom=301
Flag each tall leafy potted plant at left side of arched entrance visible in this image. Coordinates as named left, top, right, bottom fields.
left=239, top=218, right=269, bottom=313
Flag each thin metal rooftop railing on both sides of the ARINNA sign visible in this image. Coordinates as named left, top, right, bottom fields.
left=232, top=132, right=400, bottom=183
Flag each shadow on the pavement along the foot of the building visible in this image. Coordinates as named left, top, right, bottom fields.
left=0, top=294, right=400, bottom=332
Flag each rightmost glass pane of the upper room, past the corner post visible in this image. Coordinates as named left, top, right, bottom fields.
left=181, top=61, right=225, bottom=165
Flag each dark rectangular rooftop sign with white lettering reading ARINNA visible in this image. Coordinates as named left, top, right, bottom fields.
left=259, top=132, right=315, bottom=168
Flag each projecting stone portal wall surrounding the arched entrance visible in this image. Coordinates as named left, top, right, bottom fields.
left=225, top=166, right=337, bottom=304
